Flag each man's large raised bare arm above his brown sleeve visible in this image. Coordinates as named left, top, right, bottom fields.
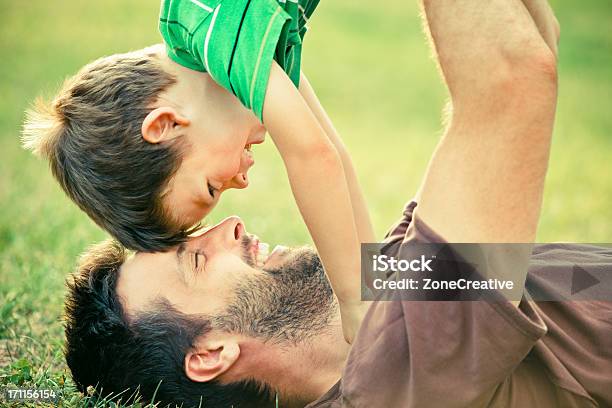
left=417, top=0, right=557, bottom=303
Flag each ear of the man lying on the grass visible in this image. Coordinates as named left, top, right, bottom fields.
left=185, top=339, right=240, bottom=382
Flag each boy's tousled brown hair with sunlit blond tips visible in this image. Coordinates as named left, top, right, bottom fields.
left=23, top=51, right=195, bottom=251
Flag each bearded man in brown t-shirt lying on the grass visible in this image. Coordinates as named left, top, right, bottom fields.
left=66, top=0, right=612, bottom=408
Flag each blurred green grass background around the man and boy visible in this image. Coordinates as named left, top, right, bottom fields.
left=0, top=0, right=612, bottom=405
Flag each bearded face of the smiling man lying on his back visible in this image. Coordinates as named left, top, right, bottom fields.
left=117, top=217, right=336, bottom=341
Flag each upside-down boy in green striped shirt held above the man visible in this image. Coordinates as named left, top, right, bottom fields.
left=24, top=0, right=374, bottom=341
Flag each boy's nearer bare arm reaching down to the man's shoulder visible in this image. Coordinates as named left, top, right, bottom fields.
left=263, top=62, right=366, bottom=343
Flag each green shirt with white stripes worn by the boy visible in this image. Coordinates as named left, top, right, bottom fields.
left=159, top=0, right=319, bottom=120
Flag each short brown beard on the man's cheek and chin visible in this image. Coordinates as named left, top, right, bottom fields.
left=214, top=247, right=336, bottom=343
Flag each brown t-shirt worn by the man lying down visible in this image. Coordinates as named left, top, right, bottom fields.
left=308, top=202, right=612, bottom=408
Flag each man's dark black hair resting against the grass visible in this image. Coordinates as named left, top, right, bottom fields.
left=64, top=240, right=274, bottom=408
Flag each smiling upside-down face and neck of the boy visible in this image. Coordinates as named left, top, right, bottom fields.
left=155, top=49, right=266, bottom=227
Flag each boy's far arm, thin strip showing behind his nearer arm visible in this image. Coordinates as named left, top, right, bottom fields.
left=299, top=72, right=376, bottom=243
